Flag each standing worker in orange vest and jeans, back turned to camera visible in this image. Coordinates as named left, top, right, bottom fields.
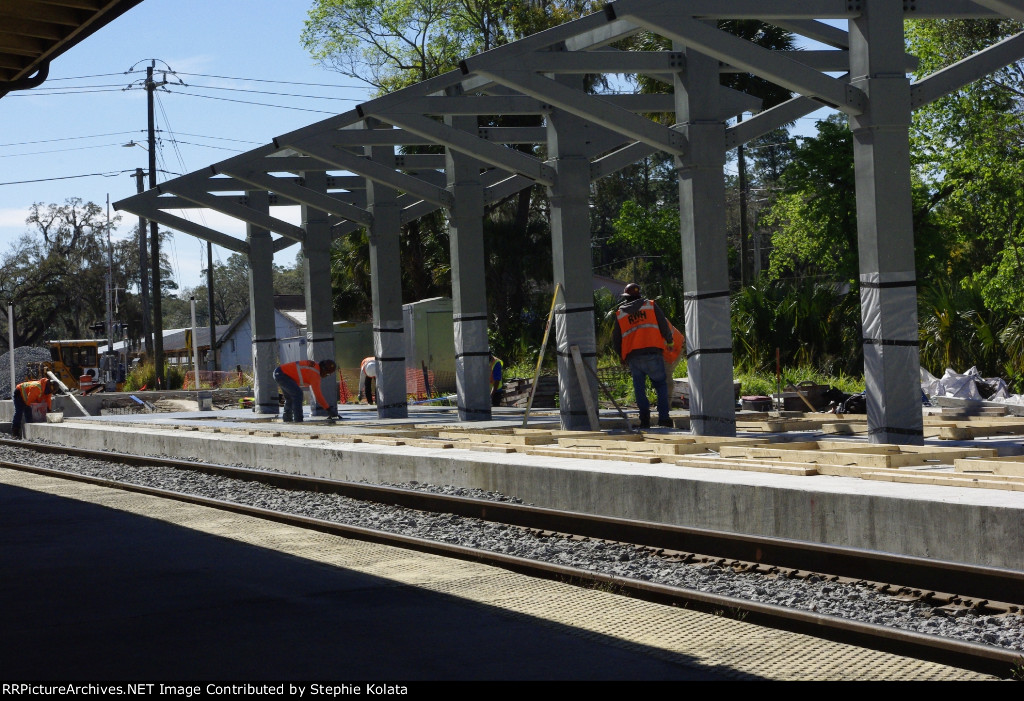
left=611, top=282, right=674, bottom=429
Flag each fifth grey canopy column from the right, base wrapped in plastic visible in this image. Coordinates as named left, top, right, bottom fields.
left=366, top=128, right=409, bottom=419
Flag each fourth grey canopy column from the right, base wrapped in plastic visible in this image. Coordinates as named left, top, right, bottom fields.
left=444, top=106, right=490, bottom=421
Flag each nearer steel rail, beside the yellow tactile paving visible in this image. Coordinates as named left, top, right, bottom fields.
left=0, top=461, right=1024, bottom=678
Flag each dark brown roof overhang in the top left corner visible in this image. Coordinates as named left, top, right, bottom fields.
left=0, top=0, right=142, bottom=97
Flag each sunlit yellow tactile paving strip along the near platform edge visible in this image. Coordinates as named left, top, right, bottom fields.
left=0, top=470, right=995, bottom=681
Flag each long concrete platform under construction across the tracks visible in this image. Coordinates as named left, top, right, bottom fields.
left=9, top=405, right=1024, bottom=571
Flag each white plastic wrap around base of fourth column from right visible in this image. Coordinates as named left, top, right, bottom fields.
left=453, top=311, right=490, bottom=421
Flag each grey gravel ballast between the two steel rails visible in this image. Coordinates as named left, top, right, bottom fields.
left=0, top=446, right=1024, bottom=653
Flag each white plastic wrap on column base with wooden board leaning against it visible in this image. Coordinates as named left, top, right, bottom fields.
left=555, top=304, right=598, bottom=431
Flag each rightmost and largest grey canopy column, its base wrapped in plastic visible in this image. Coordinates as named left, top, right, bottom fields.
left=850, top=0, right=924, bottom=445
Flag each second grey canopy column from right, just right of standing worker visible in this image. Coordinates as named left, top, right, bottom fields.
left=674, top=44, right=736, bottom=436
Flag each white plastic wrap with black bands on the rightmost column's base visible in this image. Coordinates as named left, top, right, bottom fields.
left=860, top=271, right=924, bottom=443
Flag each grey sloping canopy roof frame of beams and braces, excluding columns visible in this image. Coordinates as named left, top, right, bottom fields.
left=115, top=0, right=1024, bottom=254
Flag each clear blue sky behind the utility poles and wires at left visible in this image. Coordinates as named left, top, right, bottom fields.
left=0, top=0, right=820, bottom=288
